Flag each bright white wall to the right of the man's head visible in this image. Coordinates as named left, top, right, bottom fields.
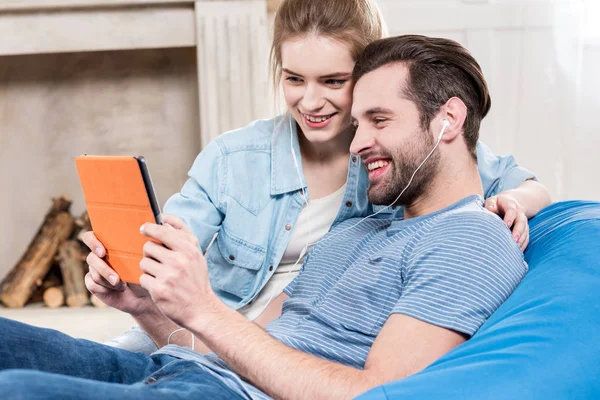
left=378, top=0, right=600, bottom=200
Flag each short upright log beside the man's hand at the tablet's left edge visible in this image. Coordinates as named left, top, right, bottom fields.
left=58, top=240, right=89, bottom=307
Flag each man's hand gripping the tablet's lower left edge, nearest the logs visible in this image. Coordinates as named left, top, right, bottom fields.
left=83, top=231, right=155, bottom=316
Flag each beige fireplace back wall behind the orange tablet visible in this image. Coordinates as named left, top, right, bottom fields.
left=0, top=48, right=200, bottom=279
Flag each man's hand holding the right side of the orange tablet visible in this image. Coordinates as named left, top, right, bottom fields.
left=140, top=214, right=219, bottom=327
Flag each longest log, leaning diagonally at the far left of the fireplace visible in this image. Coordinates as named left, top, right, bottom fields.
left=0, top=206, right=75, bottom=308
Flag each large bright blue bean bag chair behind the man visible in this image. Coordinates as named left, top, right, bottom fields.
left=358, top=201, right=600, bottom=400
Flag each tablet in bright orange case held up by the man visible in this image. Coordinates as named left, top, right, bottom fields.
left=75, top=155, right=160, bottom=284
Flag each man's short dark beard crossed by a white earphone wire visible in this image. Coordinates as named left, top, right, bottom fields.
left=369, top=131, right=440, bottom=206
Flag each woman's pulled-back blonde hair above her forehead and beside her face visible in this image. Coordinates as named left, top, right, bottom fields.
left=270, top=0, right=385, bottom=91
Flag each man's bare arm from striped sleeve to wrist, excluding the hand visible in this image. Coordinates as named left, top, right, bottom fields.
left=188, top=302, right=466, bottom=399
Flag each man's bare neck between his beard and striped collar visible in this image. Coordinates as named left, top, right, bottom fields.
left=404, top=158, right=483, bottom=219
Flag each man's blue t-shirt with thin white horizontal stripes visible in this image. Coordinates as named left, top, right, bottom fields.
left=160, top=196, right=527, bottom=398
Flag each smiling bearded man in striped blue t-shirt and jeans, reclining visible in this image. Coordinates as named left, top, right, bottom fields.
left=0, top=36, right=527, bottom=399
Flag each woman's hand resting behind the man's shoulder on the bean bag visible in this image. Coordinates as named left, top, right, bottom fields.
left=485, top=191, right=529, bottom=251
